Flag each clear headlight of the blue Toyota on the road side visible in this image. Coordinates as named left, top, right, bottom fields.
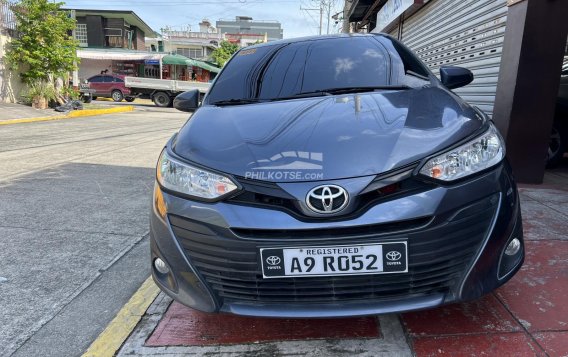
left=156, top=149, right=238, bottom=200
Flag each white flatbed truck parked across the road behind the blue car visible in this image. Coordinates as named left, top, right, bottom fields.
left=124, top=77, right=211, bottom=107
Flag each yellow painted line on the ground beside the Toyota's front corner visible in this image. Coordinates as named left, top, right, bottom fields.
left=83, top=277, right=160, bottom=357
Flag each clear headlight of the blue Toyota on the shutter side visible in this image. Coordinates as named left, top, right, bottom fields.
left=420, top=123, right=505, bottom=181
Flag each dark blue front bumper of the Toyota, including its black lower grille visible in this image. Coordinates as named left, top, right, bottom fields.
left=150, top=163, right=524, bottom=317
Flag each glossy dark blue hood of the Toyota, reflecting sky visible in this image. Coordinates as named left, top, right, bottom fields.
left=172, top=87, right=483, bottom=182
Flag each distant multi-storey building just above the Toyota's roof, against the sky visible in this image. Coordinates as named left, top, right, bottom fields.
left=216, top=16, right=284, bottom=43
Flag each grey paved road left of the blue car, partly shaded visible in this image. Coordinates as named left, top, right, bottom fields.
left=0, top=107, right=187, bottom=356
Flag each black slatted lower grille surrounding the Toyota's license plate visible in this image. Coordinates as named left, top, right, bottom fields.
left=170, top=197, right=496, bottom=303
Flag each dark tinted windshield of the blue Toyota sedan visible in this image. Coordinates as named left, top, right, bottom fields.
left=207, top=36, right=431, bottom=104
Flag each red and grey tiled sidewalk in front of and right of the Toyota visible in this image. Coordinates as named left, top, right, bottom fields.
left=107, top=165, right=568, bottom=356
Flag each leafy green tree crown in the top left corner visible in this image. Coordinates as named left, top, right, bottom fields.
left=6, top=0, right=78, bottom=84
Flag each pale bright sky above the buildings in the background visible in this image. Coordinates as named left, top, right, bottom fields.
left=61, top=0, right=344, bottom=38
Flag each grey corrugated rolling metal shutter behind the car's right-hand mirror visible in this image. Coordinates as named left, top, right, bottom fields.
left=402, top=0, right=507, bottom=116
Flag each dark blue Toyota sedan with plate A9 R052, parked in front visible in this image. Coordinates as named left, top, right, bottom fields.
left=150, top=34, right=524, bottom=317
